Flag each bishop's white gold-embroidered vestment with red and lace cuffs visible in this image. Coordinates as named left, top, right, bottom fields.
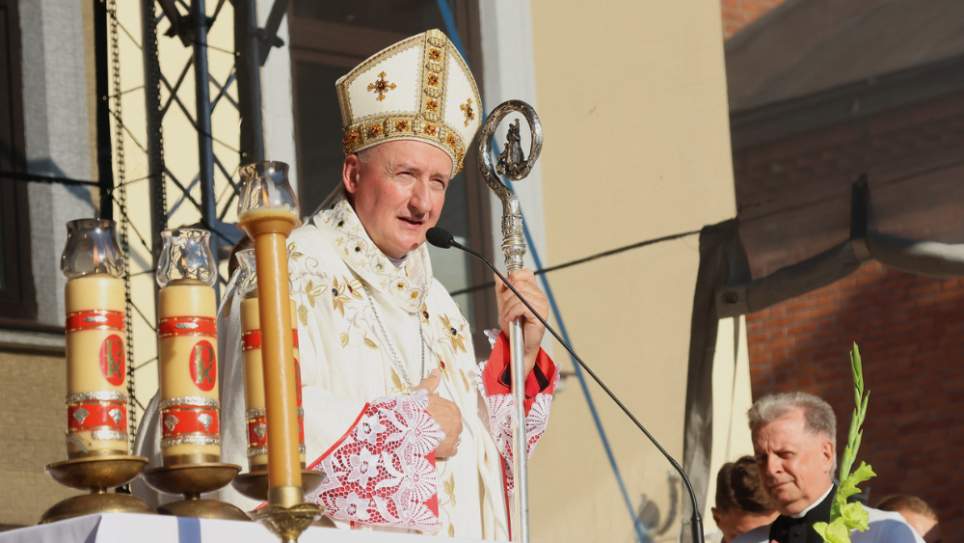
left=138, top=199, right=557, bottom=539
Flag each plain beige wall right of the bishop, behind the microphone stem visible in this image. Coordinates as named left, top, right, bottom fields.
left=531, top=0, right=735, bottom=541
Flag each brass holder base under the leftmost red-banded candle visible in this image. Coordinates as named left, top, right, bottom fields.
left=40, top=455, right=152, bottom=524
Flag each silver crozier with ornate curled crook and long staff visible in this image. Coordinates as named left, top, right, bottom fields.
left=478, top=100, right=542, bottom=543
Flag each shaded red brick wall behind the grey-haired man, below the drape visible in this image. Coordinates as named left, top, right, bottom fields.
left=747, top=263, right=964, bottom=537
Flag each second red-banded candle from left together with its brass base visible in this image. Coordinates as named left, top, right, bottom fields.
left=144, top=228, right=248, bottom=520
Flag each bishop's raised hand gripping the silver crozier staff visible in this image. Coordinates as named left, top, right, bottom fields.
left=495, top=270, right=549, bottom=377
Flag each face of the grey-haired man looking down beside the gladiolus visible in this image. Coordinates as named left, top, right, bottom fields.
left=753, top=409, right=834, bottom=515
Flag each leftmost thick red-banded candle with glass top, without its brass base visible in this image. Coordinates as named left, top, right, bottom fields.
left=61, top=219, right=130, bottom=459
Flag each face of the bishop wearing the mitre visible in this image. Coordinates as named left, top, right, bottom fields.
left=342, top=140, right=452, bottom=258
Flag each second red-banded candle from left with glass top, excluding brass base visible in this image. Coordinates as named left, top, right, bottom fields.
left=157, top=228, right=221, bottom=466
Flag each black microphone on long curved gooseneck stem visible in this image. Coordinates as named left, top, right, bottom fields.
left=425, top=226, right=703, bottom=543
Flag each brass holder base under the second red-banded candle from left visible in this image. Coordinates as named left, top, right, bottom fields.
left=144, top=462, right=250, bottom=520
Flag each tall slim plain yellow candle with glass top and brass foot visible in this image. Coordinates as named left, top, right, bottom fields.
left=238, top=162, right=321, bottom=541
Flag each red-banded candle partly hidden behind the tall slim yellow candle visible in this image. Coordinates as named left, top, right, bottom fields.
left=237, top=249, right=305, bottom=471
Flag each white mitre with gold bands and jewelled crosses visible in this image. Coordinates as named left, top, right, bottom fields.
left=335, top=29, right=482, bottom=177
